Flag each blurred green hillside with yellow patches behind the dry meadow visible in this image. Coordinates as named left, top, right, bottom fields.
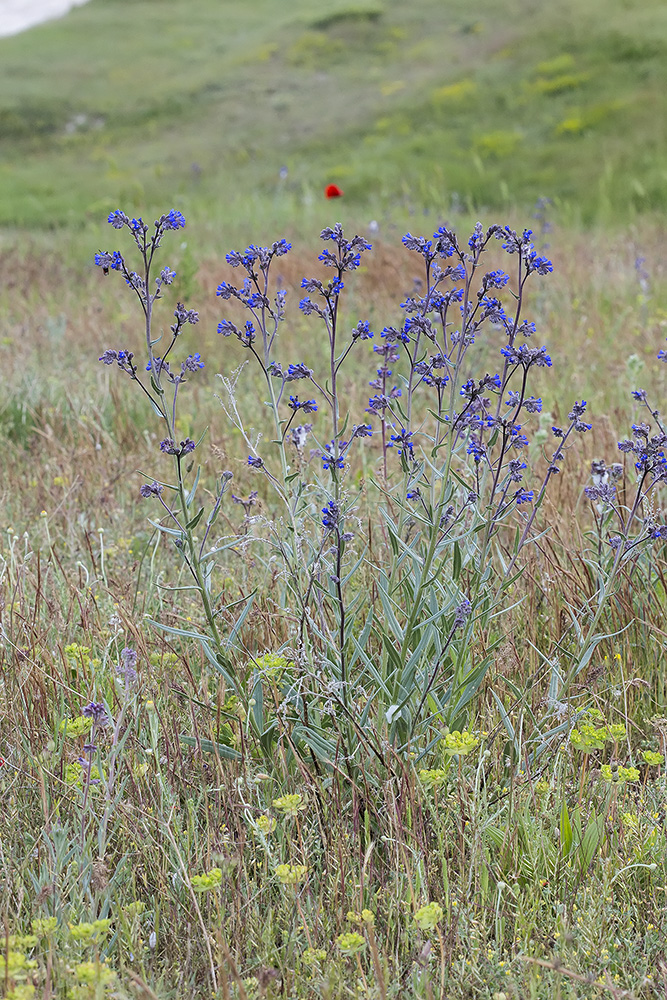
left=0, top=0, right=667, bottom=227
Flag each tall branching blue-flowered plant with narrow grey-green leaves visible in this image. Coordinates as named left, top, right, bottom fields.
left=96, top=211, right=664, bottom=770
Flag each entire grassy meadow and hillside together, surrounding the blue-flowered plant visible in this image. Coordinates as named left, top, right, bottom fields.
left=0, top=0, right=667, bottom=1000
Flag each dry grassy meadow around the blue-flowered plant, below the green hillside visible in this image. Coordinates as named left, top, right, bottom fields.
left=0, top=206, right=667, bottom=1000
